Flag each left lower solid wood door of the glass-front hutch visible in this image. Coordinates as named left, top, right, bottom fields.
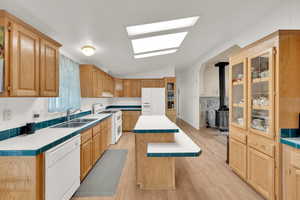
left=229, top=139, right=247, bottom=179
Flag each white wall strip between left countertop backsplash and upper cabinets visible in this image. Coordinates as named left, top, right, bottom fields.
left=0, top=98, right=112, bottom=131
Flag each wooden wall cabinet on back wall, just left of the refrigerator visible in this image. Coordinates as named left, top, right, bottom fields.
left=123, top=79, right=141, bottom=97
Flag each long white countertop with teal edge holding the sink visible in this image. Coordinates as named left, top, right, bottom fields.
left=0, top=114, right=111, bottom=156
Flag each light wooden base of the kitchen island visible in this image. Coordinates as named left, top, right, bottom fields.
left=135, top=133, right=175, bottom=190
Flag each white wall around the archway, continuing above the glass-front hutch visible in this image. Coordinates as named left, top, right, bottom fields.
left=176, top=0, right=300, bottom=129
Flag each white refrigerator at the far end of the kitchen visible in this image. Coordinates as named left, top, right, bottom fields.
left=142, top=88, right=165, bottom=115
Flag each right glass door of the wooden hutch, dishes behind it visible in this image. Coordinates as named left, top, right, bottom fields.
left=248, top=49, right=274, bottom=137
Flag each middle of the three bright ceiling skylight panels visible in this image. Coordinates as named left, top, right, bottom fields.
left=131, top=32, right=187, bottom=54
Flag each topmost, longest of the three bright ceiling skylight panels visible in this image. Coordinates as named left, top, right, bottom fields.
left=126, top=16, right=199, bottom=36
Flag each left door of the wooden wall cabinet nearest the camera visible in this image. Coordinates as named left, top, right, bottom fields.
left=11, top=23, right=40, bottom=97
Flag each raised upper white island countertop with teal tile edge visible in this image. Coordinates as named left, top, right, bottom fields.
left=132, top=115, right=179, bottom=134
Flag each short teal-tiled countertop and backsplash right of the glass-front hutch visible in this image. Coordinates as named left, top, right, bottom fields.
left=280, top=128, right=300, bottom=149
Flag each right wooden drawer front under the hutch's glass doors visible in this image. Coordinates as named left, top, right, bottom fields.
left=248, top=136, right=274, bottom=158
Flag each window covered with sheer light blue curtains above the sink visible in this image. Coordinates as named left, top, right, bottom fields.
left=48, top=55, right=80, bottom=112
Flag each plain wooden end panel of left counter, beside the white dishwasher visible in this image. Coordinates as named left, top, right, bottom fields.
left=0, top=154, right=44, bottom=200
